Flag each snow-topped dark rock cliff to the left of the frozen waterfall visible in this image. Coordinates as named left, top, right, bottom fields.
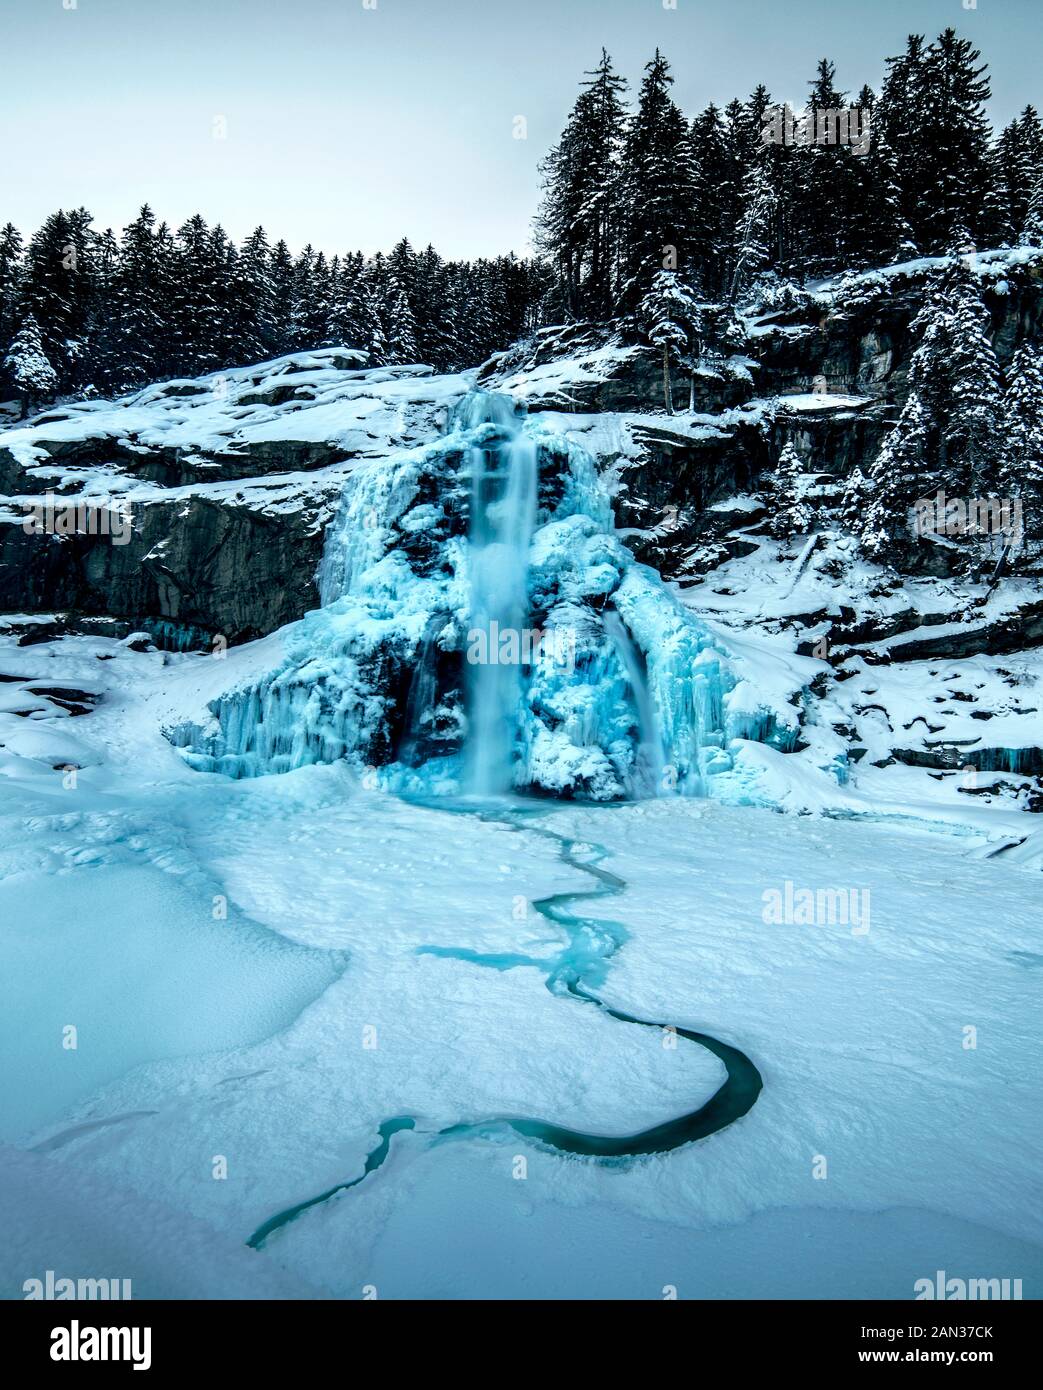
left=0, top=349, right=470, bottom=645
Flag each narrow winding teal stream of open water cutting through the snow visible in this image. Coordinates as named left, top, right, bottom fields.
left=246, top=801, right=763, bottom=1250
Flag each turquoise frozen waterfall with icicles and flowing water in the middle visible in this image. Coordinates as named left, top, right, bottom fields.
left=171, top=391, right=755, bottom=801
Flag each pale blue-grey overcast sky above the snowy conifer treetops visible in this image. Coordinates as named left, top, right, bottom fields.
left=0, top=0, right=1043, bottom=256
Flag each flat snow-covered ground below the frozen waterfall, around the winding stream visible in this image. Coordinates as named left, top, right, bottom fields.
left=0, top=625, right=1043, bottom=1298
